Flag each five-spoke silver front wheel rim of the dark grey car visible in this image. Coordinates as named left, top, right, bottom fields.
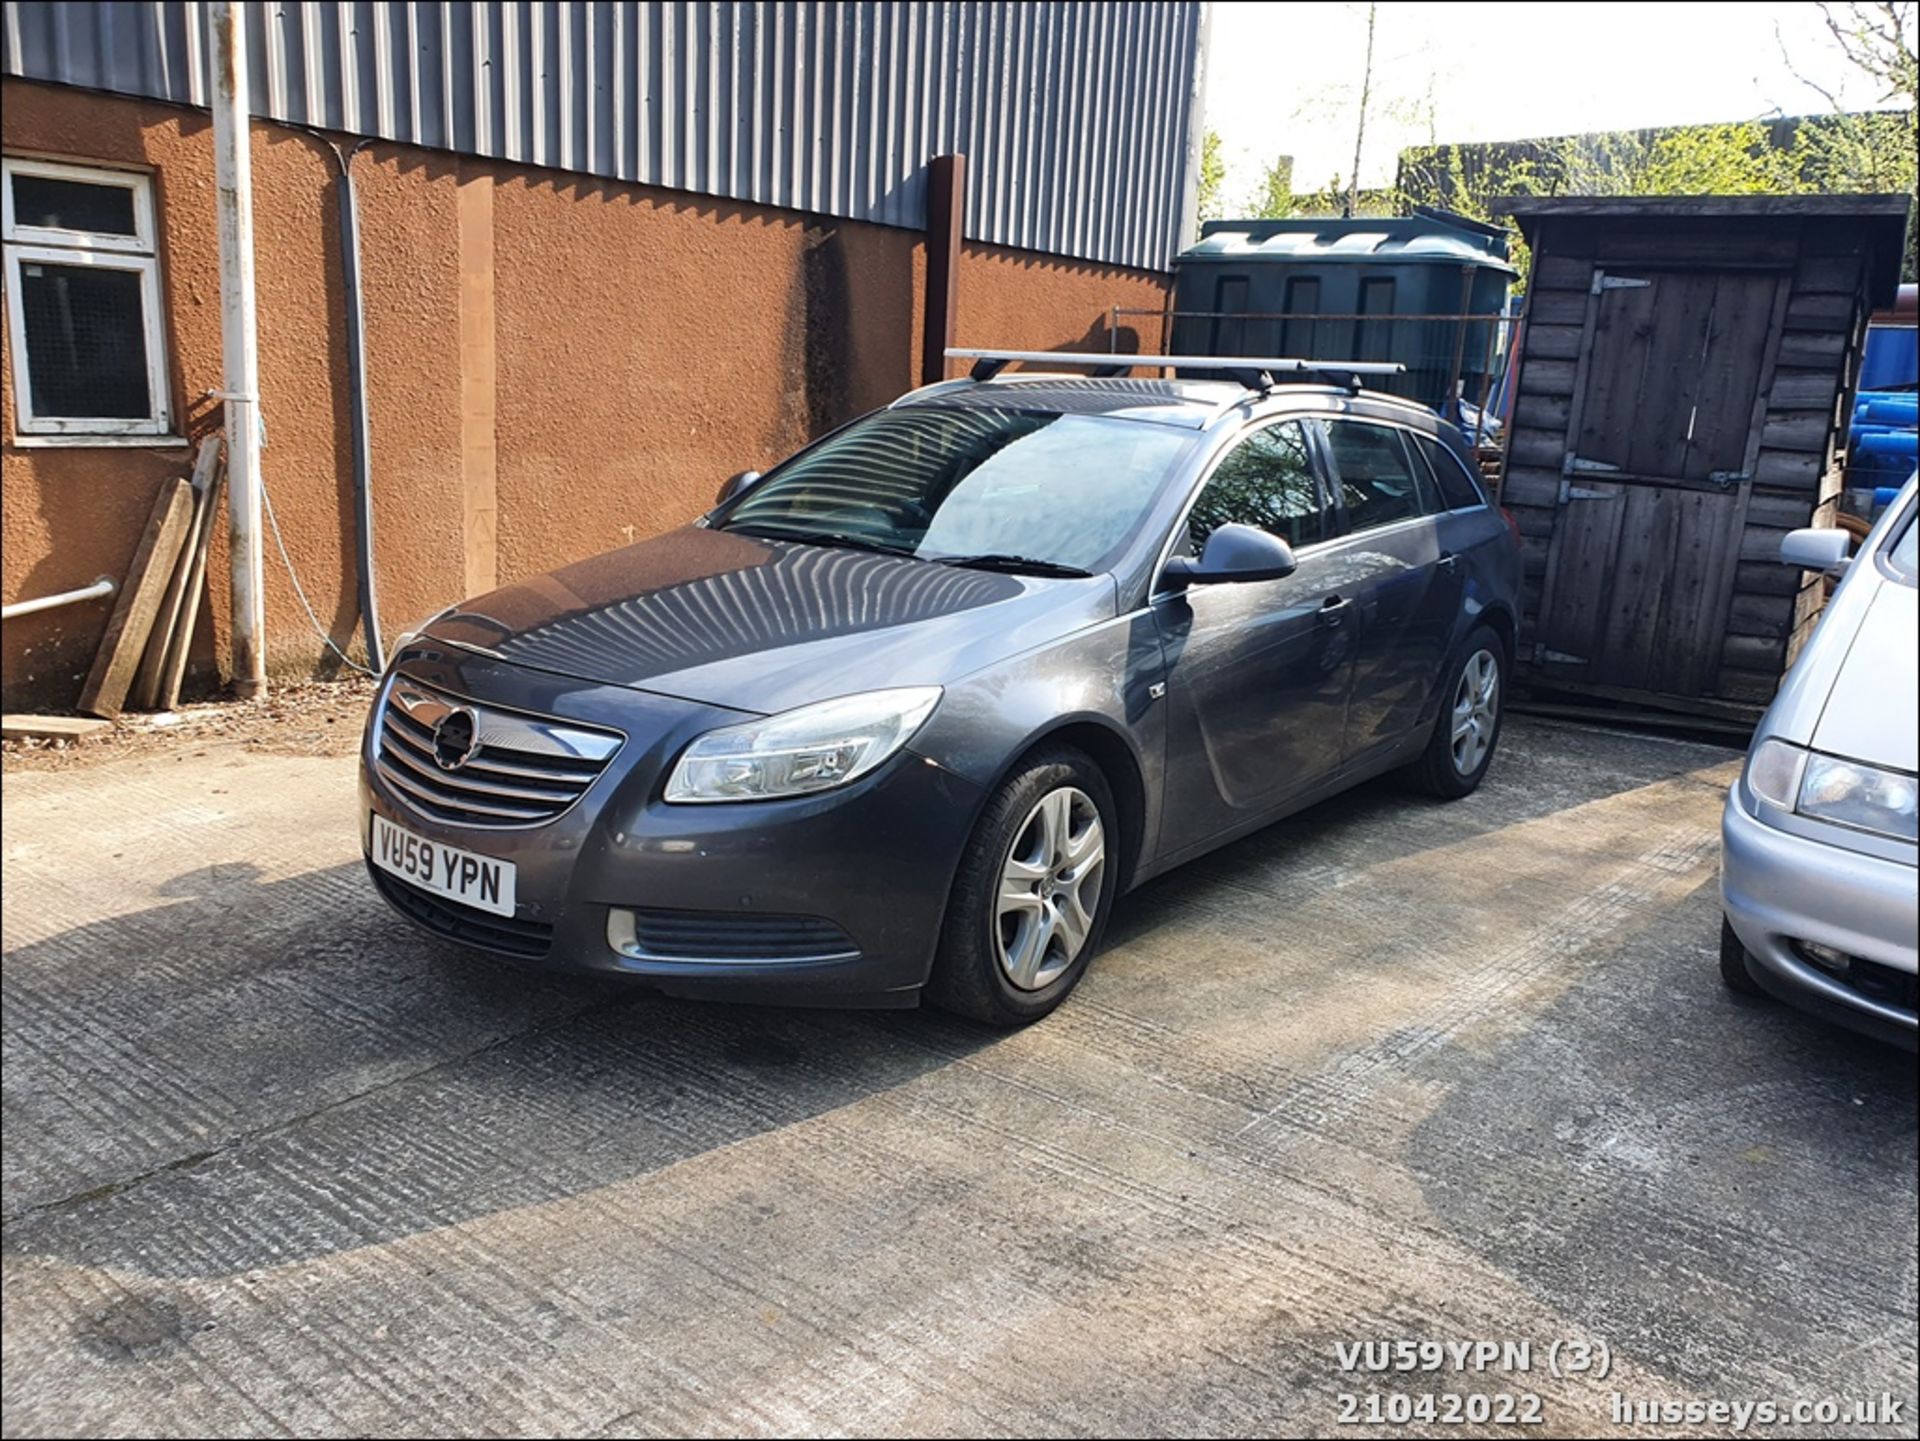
left=993, top=785, right=1106, bottom=990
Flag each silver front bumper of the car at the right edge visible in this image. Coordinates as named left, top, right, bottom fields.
left=1720, top=785, right=1920, bottom=1050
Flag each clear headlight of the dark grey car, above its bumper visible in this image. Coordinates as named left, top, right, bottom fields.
left=666, top=685, right=941, bottom=804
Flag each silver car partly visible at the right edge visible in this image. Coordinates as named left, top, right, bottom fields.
left=1720, top=480, right=1920, bottom=1050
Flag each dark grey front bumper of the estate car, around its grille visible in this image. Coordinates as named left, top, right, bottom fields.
left=359, top=643, right=981, bottom=1005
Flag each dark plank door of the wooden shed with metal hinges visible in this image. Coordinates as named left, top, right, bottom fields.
left=1523, top=269, right=1788, bottom=697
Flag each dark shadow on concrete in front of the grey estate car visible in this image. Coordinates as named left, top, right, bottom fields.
left=0, top=863, right=998, bottom=1280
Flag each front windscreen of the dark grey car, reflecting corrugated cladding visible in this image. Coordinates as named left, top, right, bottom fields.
left=716, top=407, right=1194, bottom=572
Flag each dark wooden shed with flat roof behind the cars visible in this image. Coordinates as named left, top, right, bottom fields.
left=1501, top=196, right=1908, bottom=720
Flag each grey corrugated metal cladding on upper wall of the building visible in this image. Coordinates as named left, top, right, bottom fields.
left=4, top=0, right=1202, bottom=269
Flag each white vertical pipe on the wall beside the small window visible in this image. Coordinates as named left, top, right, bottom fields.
left=207, top=0, right=267, bottom=700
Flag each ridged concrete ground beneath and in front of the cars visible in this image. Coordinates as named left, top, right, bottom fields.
left=4, top=721, right=1916, bottom=1435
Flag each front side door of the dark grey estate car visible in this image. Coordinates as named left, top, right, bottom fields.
left=1152, top=420, right=1354, bottom=852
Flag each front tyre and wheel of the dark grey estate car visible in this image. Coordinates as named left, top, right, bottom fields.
left=927, top=746, right=1121, bottom=1027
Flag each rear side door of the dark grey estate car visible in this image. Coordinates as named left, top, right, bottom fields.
left=1325, top=418, right=1461, bottom=764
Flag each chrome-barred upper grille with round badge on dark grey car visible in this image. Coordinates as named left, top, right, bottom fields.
left=374, top=679, right=620, bottom=827
